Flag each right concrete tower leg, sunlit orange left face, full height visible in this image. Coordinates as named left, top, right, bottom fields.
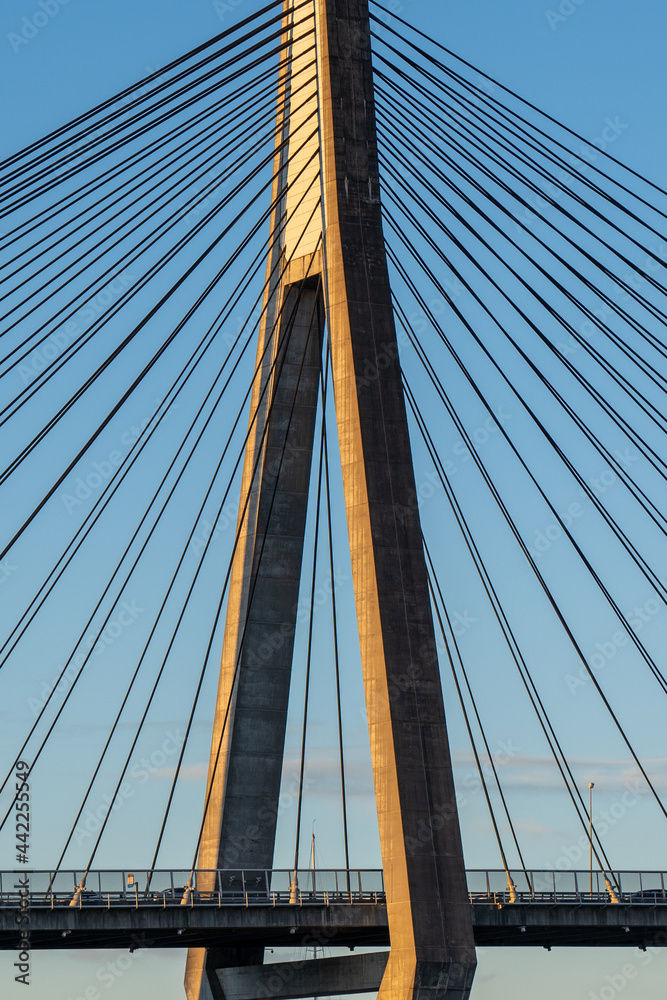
left=317, top=0, right=475, bottom=1000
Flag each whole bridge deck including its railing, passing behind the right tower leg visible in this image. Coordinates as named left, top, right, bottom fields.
left=0, top=871, right=667, bottom=950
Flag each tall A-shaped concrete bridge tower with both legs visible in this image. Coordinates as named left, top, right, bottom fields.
left=185, top=0, right=475, bottom=1000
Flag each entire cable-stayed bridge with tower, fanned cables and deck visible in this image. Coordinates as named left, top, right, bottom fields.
left=0, top=0, right=667, bottom=998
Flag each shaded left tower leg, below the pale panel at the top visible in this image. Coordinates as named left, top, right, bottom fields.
left=185, top=279, right=323, bottom=1000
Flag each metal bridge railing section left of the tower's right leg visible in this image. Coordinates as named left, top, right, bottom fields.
left=0, top=869, right=385, bottom=908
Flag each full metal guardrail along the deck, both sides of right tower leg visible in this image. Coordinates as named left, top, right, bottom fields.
left=0, top=869, right=667, bottom=909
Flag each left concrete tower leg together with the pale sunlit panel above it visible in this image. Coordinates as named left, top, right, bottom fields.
left=185, top=0, right=324, bottom=1000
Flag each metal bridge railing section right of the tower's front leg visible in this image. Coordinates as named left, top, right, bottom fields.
left=466, top=869, right=667, bottom=905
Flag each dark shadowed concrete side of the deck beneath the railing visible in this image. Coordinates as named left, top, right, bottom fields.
left=0, top=903, right=667, bottom=949
